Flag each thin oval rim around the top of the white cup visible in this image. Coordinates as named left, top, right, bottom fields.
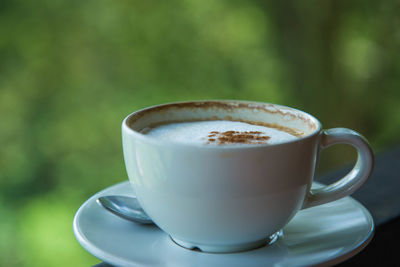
left=122, top=100, right=322, bottom=150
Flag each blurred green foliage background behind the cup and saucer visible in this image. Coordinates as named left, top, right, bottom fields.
left=0, top=0, right=400, bottom=267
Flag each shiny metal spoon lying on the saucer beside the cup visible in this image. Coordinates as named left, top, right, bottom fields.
left=97, top=196, right=154, bottom=224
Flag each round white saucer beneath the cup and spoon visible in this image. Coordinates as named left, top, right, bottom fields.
left=73, top=182, right=374, bottom=267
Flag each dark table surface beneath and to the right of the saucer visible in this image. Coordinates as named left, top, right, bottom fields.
left=90, top=146, right=400, bottom=267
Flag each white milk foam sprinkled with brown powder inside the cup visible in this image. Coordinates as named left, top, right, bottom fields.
left=144, top=120, right=298, bottom=146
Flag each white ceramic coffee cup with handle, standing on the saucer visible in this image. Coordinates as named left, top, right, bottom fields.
left=122, top=101, right=373, bottom=252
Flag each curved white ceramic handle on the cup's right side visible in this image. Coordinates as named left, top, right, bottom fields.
left=302, top=128, right=374, bottom=209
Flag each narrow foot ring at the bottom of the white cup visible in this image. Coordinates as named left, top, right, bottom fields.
left=170, top=230, right=283, bottom=253
